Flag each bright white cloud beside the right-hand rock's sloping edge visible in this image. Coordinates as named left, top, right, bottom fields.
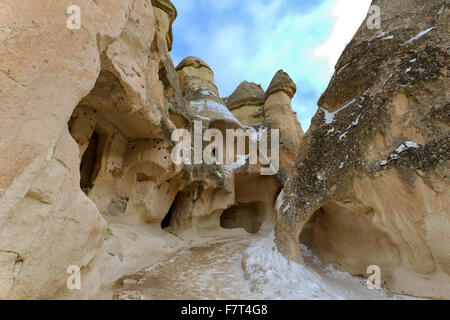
left=315, top=0, right=372, bottom=73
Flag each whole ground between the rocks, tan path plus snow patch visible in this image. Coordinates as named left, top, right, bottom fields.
left=100, top=235, right=418, bottom=300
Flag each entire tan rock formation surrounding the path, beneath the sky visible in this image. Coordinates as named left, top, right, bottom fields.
left=0, top=0, right=450, bottom=299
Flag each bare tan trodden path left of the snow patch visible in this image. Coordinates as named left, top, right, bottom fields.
left=98, top=236, right=258, bottom=300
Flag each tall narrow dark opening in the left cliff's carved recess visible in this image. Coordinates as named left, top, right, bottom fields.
left=80, top=130, right=103, bottom=194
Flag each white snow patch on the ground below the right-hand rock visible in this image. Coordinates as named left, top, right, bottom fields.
left=245, top=232, right=414, bottom=300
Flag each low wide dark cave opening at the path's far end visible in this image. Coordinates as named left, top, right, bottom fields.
left=220, top=202, right=266, bottom=233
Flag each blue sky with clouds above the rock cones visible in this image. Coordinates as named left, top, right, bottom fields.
left=172, top=0, right=371, bottom=131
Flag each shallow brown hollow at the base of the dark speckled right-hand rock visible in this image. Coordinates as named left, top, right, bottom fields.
left=300, top=200, right=399, bottom=275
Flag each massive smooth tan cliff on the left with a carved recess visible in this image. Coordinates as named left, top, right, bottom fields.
left=0, top=0, right=188, bottom=299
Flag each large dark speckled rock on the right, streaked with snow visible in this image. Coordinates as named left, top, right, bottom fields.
left=276, top=0, right=450, bottom=299
